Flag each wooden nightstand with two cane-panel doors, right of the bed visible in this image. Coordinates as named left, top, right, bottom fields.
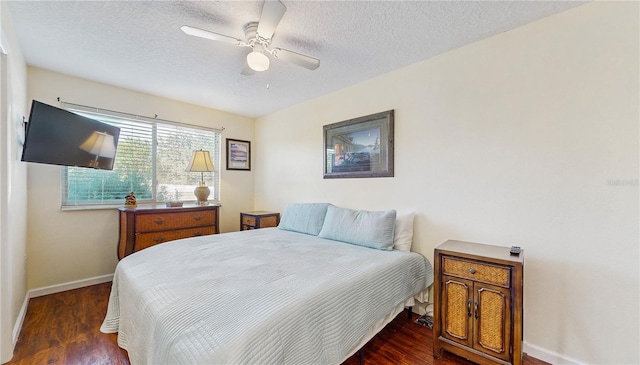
left=433, top=241, right=524, bottom=365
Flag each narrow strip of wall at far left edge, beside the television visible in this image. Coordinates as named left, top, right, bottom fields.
left=0, top=2, right=27, bottom=363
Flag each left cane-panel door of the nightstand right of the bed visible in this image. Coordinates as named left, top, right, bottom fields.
left=440, top=275, right=473, bottom=347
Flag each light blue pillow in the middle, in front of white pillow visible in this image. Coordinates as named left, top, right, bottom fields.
left=318, top=205, right=396, bottom=250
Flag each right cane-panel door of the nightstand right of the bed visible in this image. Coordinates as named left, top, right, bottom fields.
left=473, top=283, right=511, bottom=361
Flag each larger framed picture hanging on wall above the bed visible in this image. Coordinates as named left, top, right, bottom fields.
left=323, top=110, right=394, bottom=179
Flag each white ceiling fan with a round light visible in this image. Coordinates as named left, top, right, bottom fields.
left=180, top=0, right=320, bottom=75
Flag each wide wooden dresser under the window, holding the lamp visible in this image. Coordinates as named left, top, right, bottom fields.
left=118, top=205, right=219, bottom=259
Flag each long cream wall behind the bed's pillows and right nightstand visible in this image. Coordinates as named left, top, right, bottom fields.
left=255, top=2, right=640, bottom=364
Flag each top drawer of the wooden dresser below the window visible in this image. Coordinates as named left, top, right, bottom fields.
left=136, top=210, right=216, bottom=232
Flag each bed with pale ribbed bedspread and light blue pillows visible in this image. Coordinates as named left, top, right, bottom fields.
left=101, top=203, right=433, bottom=365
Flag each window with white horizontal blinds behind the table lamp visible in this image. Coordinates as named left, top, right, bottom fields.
left=61, top=103, right=221, bottom=208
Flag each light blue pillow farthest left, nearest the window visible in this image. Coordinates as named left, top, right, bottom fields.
left=278, top=203, right=331, bottom=236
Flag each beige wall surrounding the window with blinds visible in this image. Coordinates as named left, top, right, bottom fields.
left=27, top=67, right=254, bottom=289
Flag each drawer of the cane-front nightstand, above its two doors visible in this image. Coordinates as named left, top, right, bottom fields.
left=442, top=256, right=511, bottom=288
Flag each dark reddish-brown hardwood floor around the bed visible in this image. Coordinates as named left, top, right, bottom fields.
left=7, top=283, right=546, bottom=365
